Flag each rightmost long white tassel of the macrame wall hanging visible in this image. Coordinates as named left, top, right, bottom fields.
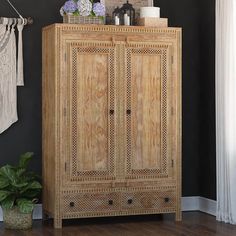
left=17, top=22, right=24, bottom=86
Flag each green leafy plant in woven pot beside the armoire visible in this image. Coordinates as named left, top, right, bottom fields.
left=0, top=152, right=42, bottom=229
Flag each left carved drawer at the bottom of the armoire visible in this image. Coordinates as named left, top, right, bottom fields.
left=63, top=193, right=120, bottom=213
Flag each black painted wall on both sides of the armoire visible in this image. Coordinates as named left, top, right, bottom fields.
left=0, top=0, right=215, bottom=199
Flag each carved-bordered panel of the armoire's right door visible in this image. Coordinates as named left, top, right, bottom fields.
left=125, top=42, right=172, bottom=179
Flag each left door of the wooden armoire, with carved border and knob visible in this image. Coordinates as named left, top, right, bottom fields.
left=60, top=36, right=118, bottom=187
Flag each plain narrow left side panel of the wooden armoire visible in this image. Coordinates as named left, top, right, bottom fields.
left=42, top=26, right=57, bottom=222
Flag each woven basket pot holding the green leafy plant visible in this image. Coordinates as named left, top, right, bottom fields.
left=3, top=207, right=32, bottom=229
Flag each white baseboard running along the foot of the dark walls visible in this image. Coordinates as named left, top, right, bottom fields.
left=0, top=196, right=216, bottom=221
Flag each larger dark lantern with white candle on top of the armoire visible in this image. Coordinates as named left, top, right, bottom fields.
left=120, top=1, right=135, bottom=25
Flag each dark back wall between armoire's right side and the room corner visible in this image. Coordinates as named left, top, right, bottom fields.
left=156, top=0, right=200, bottom=196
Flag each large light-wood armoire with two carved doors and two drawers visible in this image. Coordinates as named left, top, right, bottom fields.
left=42, top=24, right=181, bottom=228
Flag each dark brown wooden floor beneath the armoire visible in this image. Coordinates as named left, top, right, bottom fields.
left=0, top=212, right=236, bottom=236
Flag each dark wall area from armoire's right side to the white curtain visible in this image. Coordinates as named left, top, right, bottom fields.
left=155, top=0, right=216, bottom=199
